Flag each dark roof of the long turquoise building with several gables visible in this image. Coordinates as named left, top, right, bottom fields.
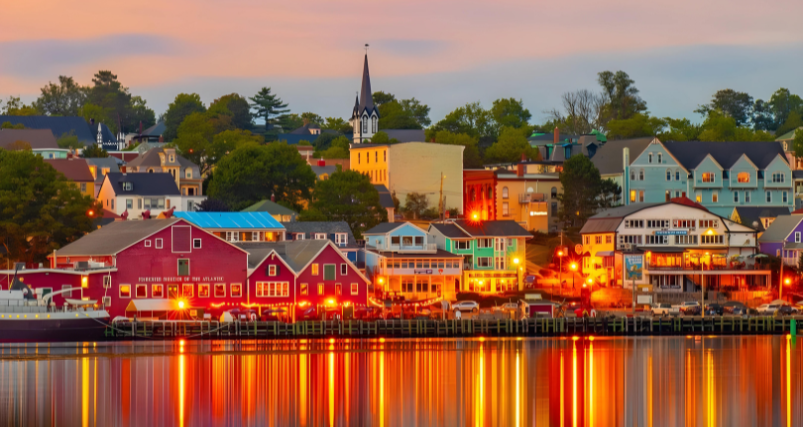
left=664, top=141, right=786, bottom=170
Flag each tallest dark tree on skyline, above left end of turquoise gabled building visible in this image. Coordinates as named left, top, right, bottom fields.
left=597, top=71, right=647, bottom=126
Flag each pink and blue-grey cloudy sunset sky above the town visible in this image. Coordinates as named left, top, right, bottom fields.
left=0, top=0, right=803, bottom=123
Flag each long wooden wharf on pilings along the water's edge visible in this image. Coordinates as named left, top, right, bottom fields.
left=105, top=316, right=803, bottom=340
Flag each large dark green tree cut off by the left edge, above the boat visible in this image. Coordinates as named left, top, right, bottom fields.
left=0, top=150, right=102, bottom=263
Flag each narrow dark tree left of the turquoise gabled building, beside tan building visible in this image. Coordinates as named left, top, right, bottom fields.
left=558, top=156, right=602, bottom=227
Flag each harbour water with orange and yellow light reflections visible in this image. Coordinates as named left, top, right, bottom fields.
left=0, top=336, right=803, bottom=426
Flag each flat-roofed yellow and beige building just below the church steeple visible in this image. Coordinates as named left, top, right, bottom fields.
left=350, top=142, right=464, bottom=212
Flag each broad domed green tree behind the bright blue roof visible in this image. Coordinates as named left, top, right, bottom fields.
left=208, top=142, right=315, bottom=211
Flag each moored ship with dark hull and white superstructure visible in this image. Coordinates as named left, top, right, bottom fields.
left=0, top=271, right=109, bottom=343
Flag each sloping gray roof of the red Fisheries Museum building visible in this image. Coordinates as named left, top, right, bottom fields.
left=56, top=218, right=183, bottom=256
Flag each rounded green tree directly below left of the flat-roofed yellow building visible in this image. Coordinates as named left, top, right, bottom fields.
left=302, top=171, right=388, bottom=239
